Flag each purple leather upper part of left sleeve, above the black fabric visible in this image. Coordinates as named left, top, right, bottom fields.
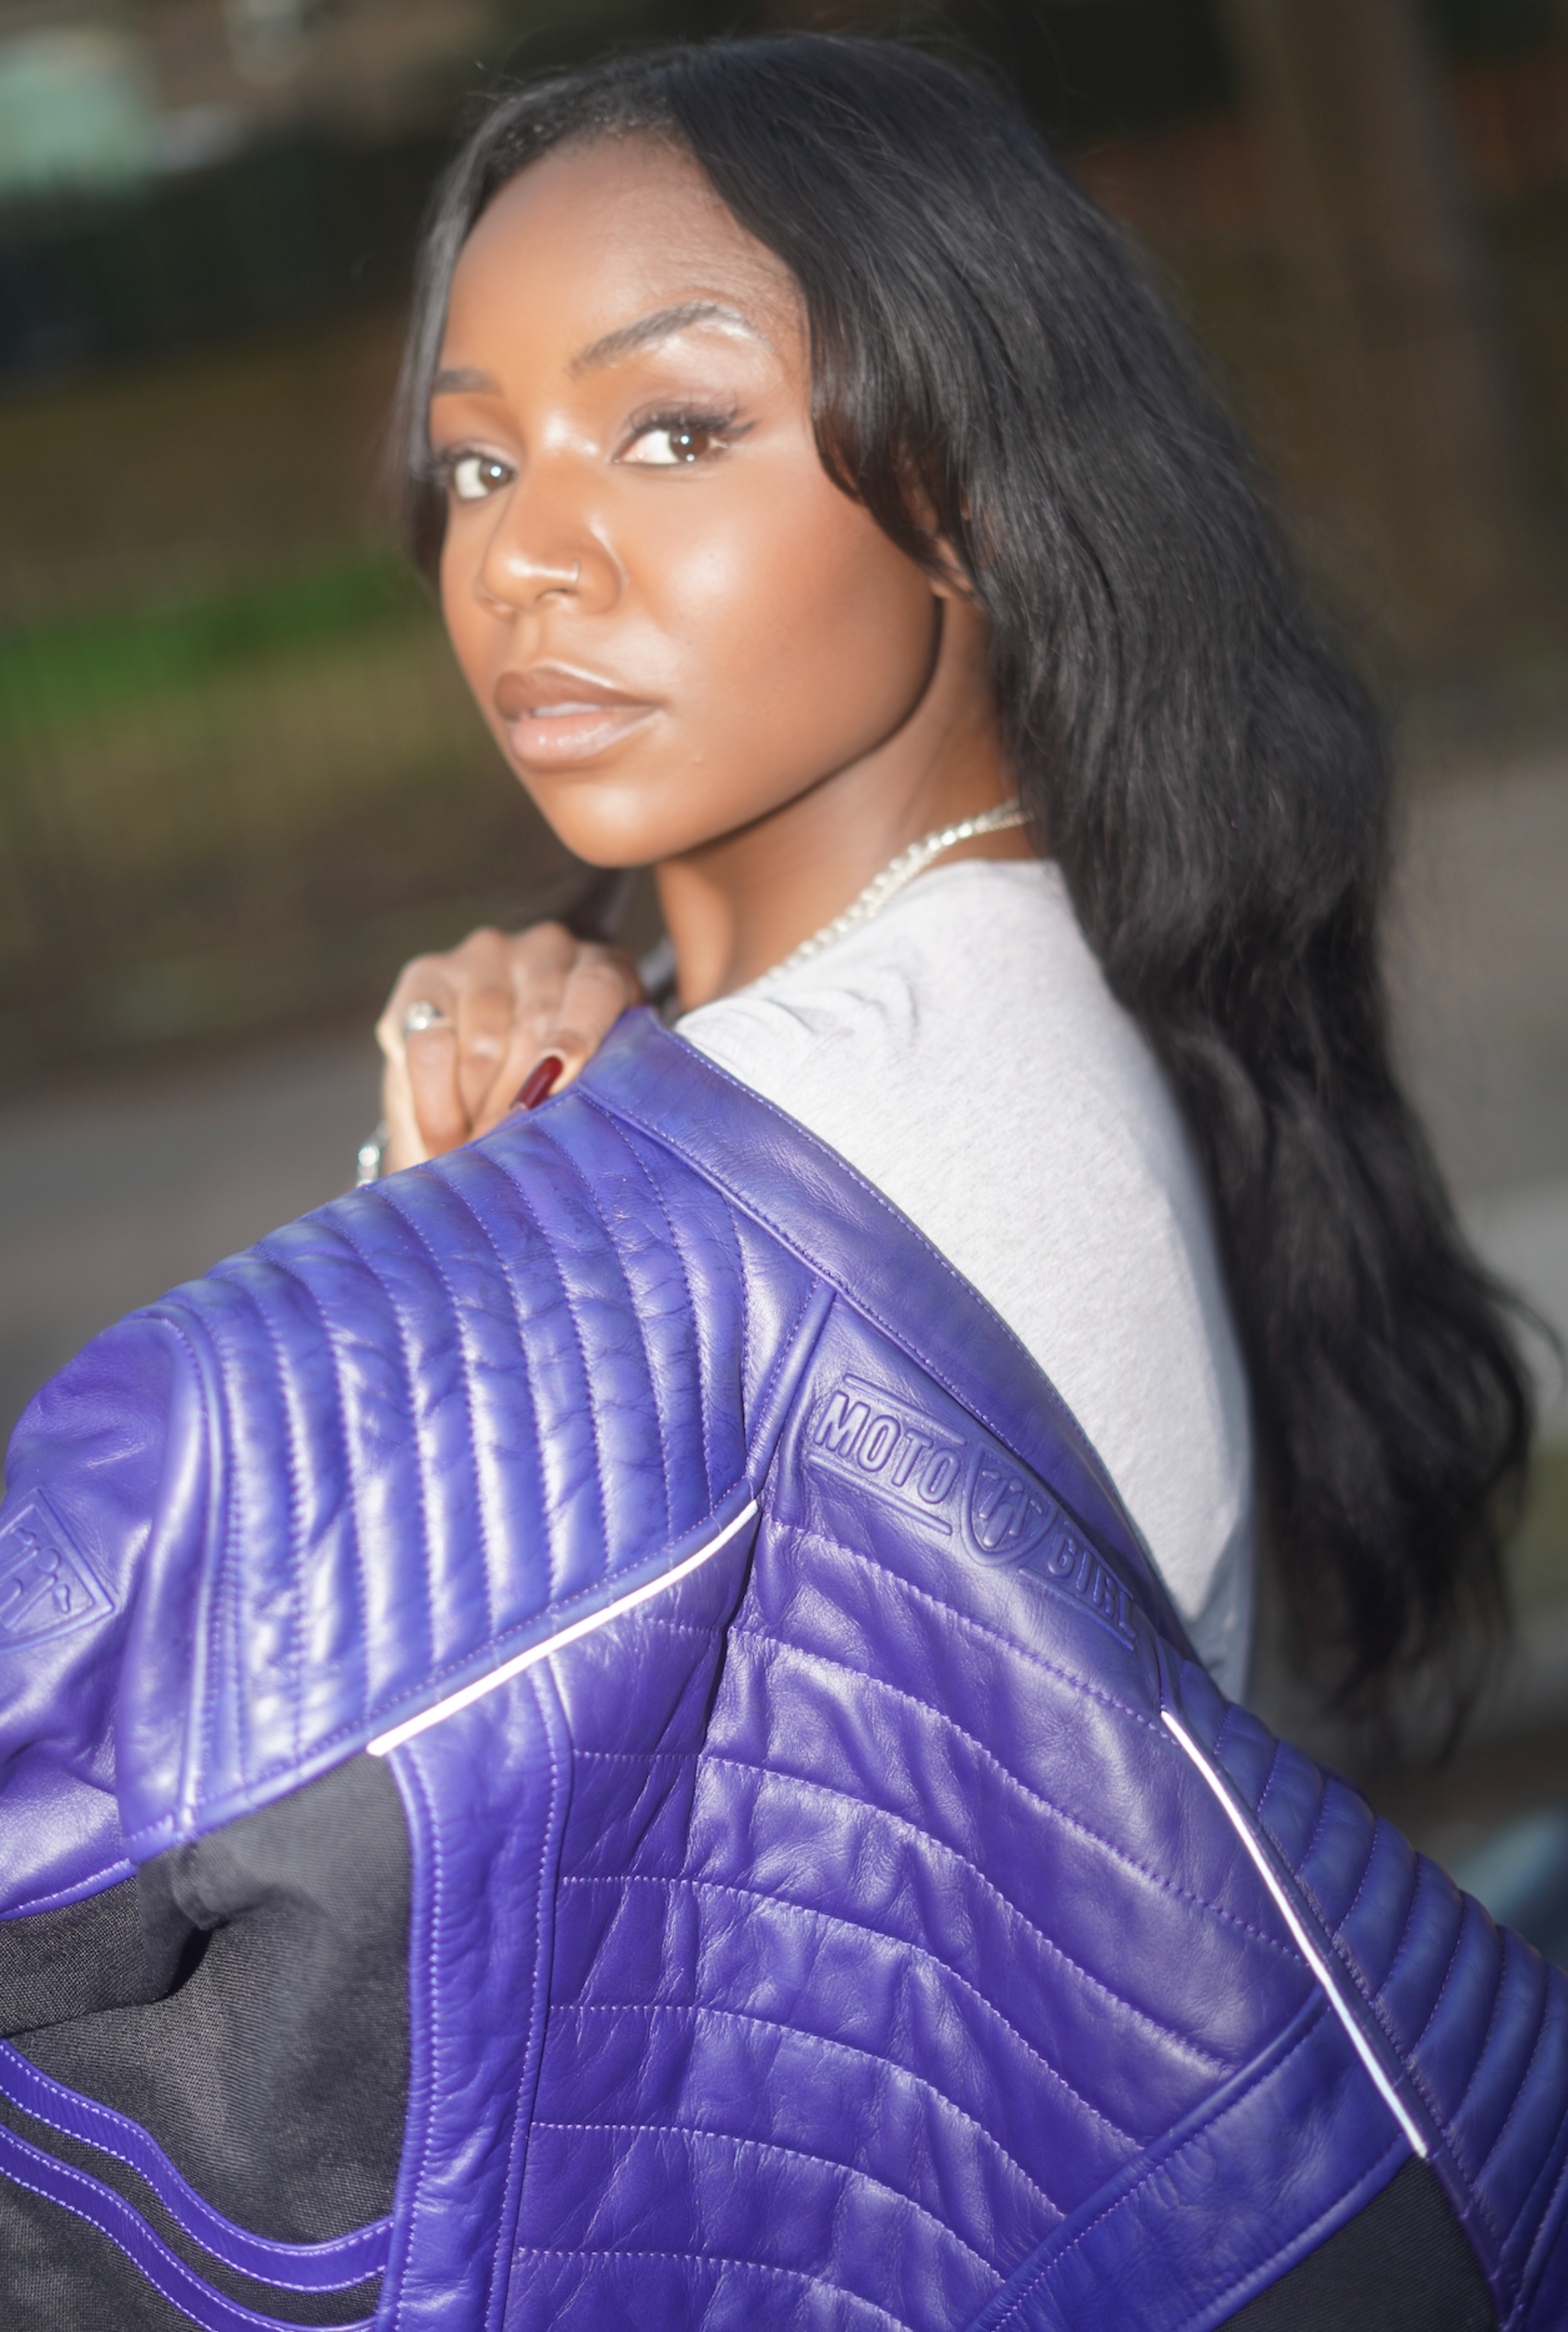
left=0, top=1101, right=779, bottom=1912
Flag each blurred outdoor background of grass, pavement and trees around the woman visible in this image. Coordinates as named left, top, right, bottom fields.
left=0, top=0, right=1568, bottom=1921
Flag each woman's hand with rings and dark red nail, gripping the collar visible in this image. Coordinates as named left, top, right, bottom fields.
left=376, top=923, right=642, bottom=1173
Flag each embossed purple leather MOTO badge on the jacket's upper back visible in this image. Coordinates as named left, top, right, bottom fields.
left=805, top=1376, right=1136, bottom=1644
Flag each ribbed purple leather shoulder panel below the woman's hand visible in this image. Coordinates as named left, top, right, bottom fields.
left=98, top=1063, right=810, bottom=1859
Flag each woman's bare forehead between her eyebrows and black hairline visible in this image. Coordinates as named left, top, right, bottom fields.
left=446, top=138, right=798, bottom=361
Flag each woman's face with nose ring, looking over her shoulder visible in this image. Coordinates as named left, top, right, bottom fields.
left=430, top=140, right=940, bottom=865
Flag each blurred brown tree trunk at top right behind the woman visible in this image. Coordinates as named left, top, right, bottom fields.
left=1220, top=0, right=1535, bottom=648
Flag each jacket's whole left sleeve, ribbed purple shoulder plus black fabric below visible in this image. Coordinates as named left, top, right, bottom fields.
left=0, top=1096, right=807, bottom=2332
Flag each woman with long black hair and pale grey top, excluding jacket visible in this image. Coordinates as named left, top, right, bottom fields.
left=381, top=27, right=1528, bottom=1712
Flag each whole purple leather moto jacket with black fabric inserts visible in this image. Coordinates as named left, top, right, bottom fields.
left=0, top=1014, right=1568, bottom=2332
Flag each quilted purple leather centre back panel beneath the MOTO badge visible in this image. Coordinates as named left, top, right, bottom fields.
left=508, top=1306, right=1334, bottom=2332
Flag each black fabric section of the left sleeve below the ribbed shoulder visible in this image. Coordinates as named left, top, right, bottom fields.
left=0, top=1756, right=410, bottom=2332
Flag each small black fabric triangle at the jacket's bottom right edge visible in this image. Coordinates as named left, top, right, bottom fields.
left=1225, top=2162, right=1498, bottom=2332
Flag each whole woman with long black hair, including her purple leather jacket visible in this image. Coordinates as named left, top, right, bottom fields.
left=0, top=40, right=1568, bottom=2332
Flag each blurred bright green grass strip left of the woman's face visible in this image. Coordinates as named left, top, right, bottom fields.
left=0, top=550, right=436, bottom=744
